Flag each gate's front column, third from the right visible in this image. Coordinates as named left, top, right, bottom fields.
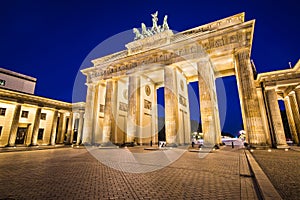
left=164, top=66, right=178, bottom=145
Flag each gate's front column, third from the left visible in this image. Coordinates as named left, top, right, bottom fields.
left=126, top=75, right=140, bottom=142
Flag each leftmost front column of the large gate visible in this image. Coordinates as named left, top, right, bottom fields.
left=82, top=83, right=95, bottom=144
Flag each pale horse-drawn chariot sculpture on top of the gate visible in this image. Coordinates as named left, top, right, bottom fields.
left=133, top=11, right=169, bottom=40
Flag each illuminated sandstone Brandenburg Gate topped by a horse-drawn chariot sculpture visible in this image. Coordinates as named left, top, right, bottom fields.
left=82, top=12, right=297, bottom=147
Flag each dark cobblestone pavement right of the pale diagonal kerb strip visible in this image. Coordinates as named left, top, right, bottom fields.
left=252, top=149, right=300, bottom=200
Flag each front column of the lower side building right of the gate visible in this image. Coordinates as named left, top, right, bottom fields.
left=266, top=89, right=287, bottom=148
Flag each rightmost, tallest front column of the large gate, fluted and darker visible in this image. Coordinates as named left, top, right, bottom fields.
left=235, top=49, right=267, bottom=146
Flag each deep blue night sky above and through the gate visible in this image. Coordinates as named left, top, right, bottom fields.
left=0, top=0, right=300, bottom=134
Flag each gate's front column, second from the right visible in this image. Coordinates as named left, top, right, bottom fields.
left=197, top=59, right=221, bottom=147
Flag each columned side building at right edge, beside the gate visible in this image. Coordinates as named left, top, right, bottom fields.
left=255, top=60, right=300, bottom=147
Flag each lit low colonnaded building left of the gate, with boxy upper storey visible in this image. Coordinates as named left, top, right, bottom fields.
left=0, top=68, right=85, bottom=147
